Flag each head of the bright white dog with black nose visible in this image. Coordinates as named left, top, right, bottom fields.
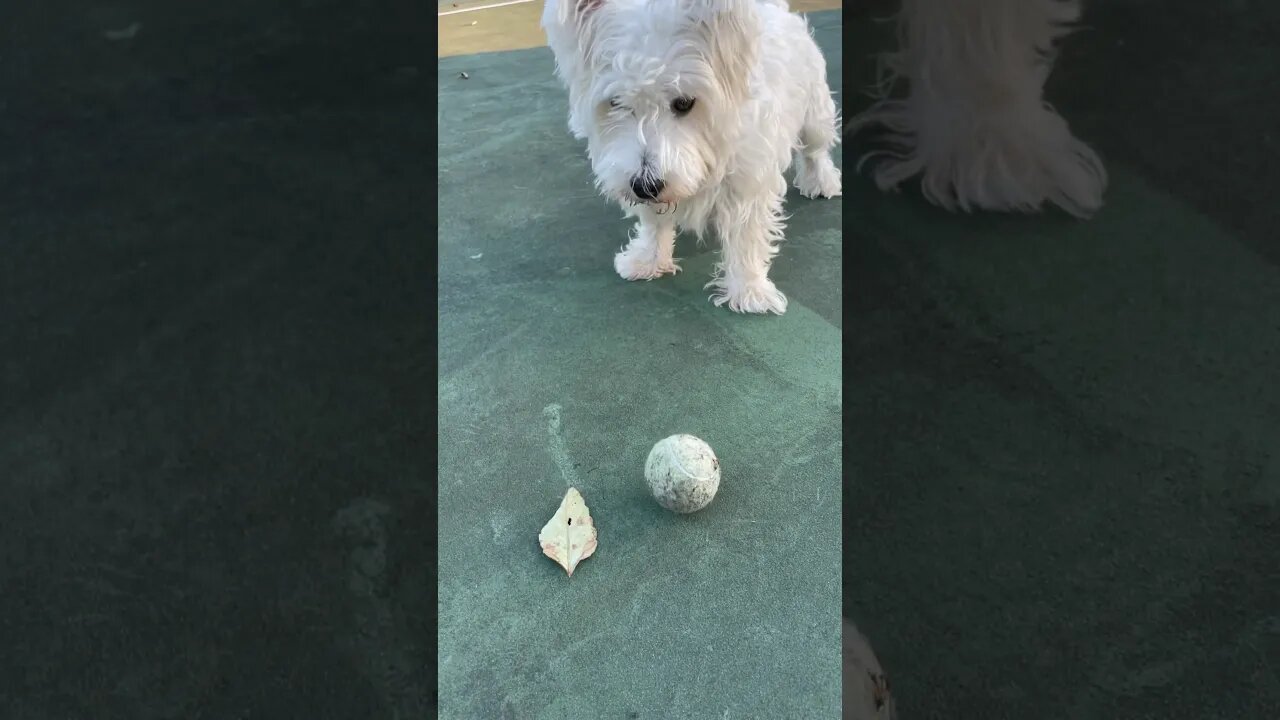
left=561, top=0, right=759, bottom=204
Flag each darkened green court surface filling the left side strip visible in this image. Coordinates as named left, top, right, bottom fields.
left=0, top=0, right=435, bottom=720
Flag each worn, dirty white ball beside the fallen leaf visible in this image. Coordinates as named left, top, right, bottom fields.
left=644, top=434, right=719, bottom=512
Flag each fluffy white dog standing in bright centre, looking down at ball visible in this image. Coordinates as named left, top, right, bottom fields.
left=543, top=0, right=840, bottom=314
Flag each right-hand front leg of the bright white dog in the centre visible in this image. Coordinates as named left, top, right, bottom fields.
left=707, top=190, right=787, bottom=315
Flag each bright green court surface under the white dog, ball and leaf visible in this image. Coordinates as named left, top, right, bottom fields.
left=439, top=12, right=841, bottom=720
